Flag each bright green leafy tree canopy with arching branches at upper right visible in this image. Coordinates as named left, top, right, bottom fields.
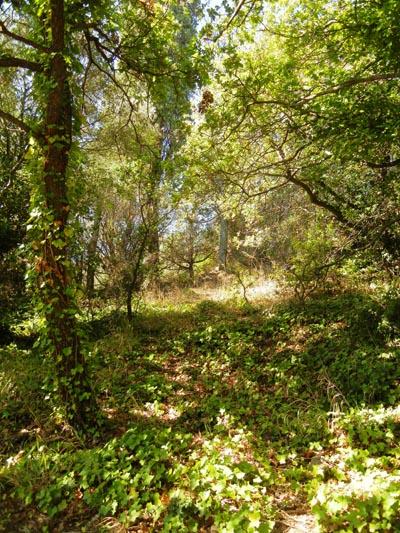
left=184, top=2, right=399, bottom=274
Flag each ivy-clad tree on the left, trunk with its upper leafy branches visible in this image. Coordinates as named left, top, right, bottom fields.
left=0, top=0, right=205, bottom=429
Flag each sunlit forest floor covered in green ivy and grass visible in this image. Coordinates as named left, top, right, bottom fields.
left=0, top=284, right=400, bottom=533
